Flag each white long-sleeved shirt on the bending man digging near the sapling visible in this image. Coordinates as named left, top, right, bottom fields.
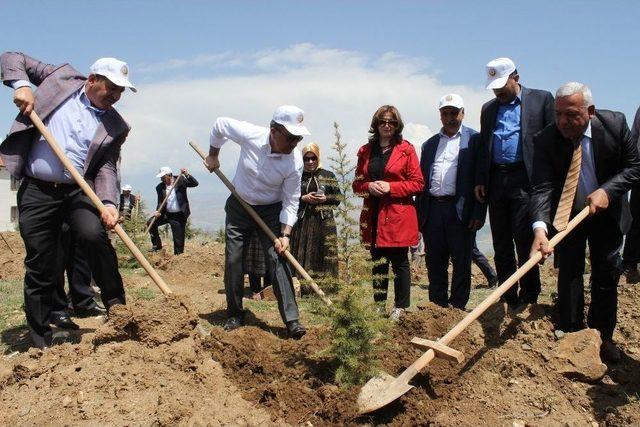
left=210, top=117, right=303, bottom=226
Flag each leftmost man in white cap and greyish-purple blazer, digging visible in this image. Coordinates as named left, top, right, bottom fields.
left=0, top=52, right=135, bottom=348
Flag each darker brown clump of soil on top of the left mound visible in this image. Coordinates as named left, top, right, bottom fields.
left=93, top=295, right=198, bottom=346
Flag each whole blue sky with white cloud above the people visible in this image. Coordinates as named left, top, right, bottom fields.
left=0, top=0, right=640, bottom=241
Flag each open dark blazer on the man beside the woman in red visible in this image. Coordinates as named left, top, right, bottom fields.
left=416, top=125, right=487, bottom=230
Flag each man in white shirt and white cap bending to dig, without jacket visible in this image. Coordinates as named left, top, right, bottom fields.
left=205, top=105, right=309, bottom=339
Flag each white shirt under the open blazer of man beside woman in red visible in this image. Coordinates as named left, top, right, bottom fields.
left=429, top=130, right=461, bottom=197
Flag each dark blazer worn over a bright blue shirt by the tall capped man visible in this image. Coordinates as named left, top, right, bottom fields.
left=476, top=86, right=555, bottom=191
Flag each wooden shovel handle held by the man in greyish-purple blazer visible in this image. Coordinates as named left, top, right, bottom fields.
left=29, top=111, right=173, bottom=295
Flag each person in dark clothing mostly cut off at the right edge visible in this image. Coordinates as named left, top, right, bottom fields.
left=622, top=108, right=640, bottom=283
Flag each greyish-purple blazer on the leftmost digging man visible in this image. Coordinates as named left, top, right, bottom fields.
left=0, top=52, right=130, bottom=206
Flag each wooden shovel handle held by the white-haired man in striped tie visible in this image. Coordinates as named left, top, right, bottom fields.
left=398, top=206, right=589, bottom=381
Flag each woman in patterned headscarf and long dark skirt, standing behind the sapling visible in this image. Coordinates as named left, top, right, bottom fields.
left=291, top=142, right=342, bottom=276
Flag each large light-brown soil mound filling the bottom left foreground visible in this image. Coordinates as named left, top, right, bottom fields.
left=0, top=297, right=270, bottom=425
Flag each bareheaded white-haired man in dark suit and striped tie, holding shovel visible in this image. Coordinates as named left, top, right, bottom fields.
left=531, top=82, right=640, bottom=361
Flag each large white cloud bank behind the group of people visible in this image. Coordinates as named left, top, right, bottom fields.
left=115, top=44, right=490, bottom=231
